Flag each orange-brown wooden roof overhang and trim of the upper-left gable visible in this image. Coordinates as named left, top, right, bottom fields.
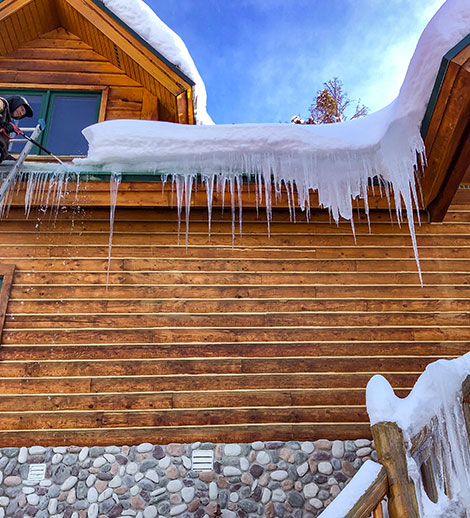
left=0, top=0, right=194, bottom=123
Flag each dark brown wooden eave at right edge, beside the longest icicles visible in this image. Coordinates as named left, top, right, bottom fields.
left=421, top=34, right=470, bottom=222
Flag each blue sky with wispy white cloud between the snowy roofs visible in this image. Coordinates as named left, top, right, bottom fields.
left=146, top=0, right=443, bottom=124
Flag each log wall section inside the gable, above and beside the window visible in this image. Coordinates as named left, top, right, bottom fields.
left=0, top=27, right=178, bottom=122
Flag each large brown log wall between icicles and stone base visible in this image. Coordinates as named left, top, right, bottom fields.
left=0, top=190, right=470, bottom=446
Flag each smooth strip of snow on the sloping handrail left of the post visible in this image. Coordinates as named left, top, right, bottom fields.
left=318, top=460, right=382, bottom=518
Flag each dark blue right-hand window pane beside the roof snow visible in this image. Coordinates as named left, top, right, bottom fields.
left=45, top=94, right=100, bottom=155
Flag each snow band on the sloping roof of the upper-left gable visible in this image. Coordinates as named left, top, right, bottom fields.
left=102, top=0, right=213, bottom=124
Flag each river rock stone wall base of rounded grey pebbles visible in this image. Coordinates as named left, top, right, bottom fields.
left=0, top=439, right=376, bottom=518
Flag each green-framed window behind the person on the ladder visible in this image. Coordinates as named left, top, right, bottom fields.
left=0, top=90, right=101, bottom=155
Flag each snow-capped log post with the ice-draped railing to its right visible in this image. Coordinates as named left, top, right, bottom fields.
left=367, top=353, right=470, bottom=518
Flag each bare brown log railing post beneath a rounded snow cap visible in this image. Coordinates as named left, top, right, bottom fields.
left=371, top=422, right=419, bottom=518
